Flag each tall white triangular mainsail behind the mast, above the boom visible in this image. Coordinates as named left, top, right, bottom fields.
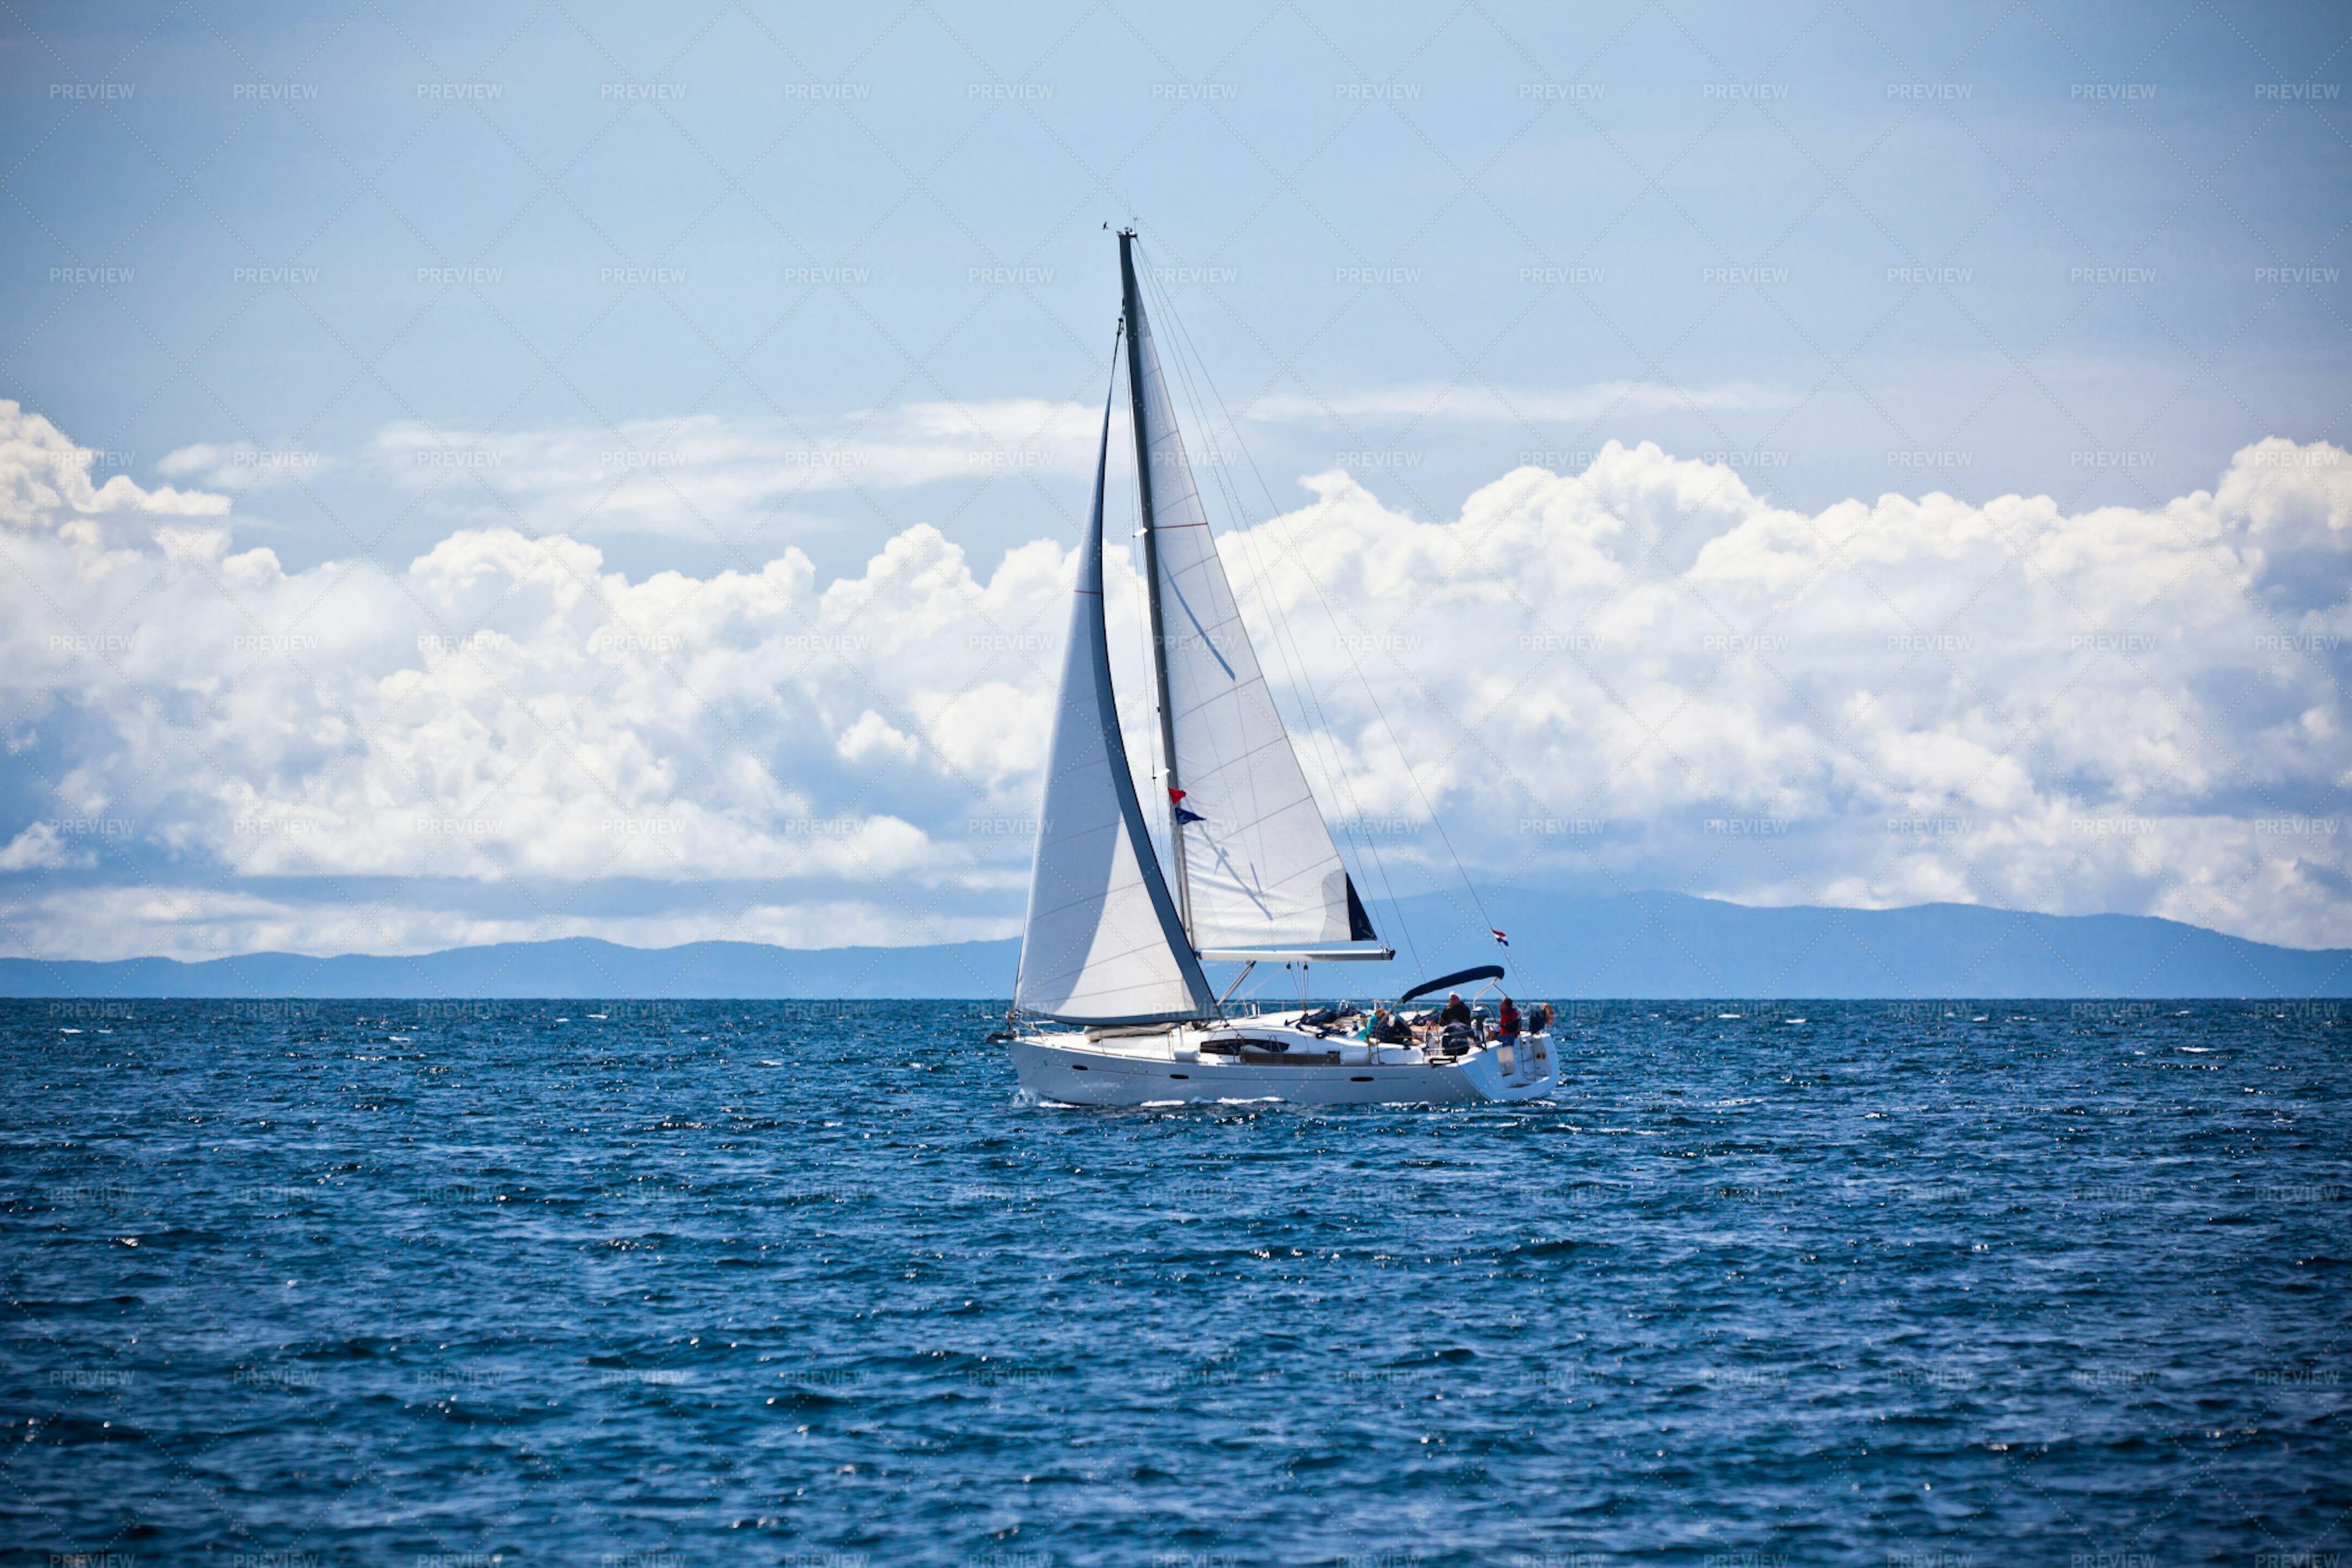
left=1120, top=235, right=1385, bottom=957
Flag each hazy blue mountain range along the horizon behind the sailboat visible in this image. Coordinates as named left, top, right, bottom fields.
left=0, top=891, right=2352, bottom=999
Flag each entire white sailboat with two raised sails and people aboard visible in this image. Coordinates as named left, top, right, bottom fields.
left=1005, top=230, right=1557, bottom=1105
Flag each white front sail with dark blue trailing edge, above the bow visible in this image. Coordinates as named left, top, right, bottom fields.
left=1014, top=350, right=1213, bottom=1023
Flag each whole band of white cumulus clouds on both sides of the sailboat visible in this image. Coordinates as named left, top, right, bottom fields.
left=0, top=404, right=2352, bottom=957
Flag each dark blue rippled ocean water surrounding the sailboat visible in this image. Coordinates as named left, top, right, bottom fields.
left=0, top=1001, right=2352, bottom=1568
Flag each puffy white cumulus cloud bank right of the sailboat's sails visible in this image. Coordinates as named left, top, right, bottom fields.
left=1227, top=440, right=2352, bottom=945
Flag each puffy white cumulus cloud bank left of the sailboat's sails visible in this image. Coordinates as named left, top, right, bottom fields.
left=0, top=394, right=1082, bottom=952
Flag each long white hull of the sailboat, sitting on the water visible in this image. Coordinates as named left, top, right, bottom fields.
left=1011, top=1025, right=1559, bottom=1105
